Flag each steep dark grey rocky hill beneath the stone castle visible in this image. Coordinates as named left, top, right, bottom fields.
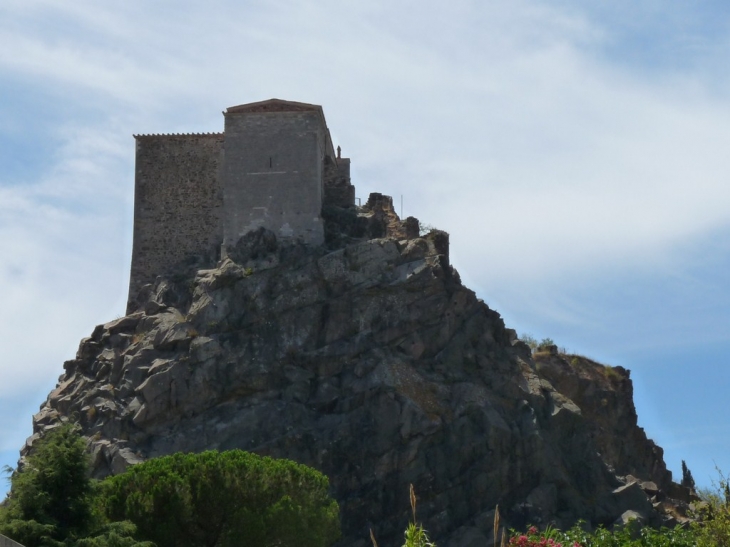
left=22, top=195, right=691, bottom=547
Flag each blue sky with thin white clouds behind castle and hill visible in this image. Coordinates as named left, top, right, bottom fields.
left=0, top=0, right=730, bottom=494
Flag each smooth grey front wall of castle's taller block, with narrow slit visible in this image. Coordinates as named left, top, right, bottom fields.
left=222, top=110, right=331, bottom=247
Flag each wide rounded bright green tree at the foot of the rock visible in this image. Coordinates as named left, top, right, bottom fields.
left=102, top=450, right=339, bottom=547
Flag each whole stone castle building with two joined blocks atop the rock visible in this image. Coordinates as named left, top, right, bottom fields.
left=127, top=99, right=355, bottom=313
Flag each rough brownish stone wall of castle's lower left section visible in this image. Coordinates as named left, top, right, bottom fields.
left=127, top=134, right=223, bottom=312
